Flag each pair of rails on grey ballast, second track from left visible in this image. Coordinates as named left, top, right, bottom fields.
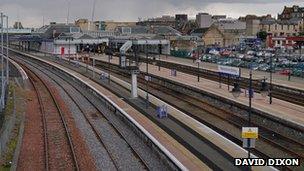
left=14, top=55, right=152, bottom=170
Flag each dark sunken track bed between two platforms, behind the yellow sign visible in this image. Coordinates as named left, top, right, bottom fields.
left=94, top=60, right=304, bottom=170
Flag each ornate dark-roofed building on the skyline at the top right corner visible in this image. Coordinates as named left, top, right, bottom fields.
left=278, top=5, right=304, bottom=20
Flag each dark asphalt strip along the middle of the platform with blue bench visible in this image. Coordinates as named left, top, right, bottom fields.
left=13, top=51, right=248, bottom=170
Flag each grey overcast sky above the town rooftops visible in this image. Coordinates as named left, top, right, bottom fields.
left=0, top=0, right=304, bottom=27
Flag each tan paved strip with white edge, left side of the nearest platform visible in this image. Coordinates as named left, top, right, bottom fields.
left=11, top=48, right=211, bottom=170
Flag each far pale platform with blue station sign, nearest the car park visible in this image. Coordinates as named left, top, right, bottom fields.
left=94, top=55, right=304, bottom=127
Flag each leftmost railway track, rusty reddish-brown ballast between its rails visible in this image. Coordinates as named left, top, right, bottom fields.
left=19, top=63, right=79, bottom=170
